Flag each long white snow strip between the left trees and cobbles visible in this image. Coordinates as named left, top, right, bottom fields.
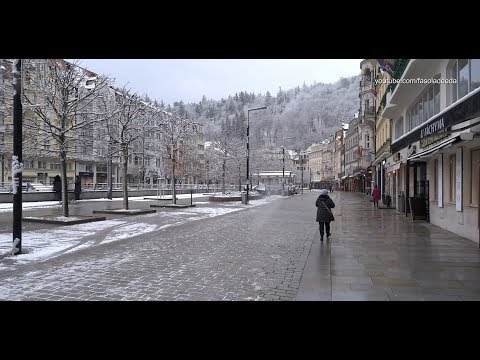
left=0, top=194, right=282, bottom=270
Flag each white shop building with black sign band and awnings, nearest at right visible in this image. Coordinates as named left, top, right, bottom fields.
left=381, top=59, right=480, bottom=242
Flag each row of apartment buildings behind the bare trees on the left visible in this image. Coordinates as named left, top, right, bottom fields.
left=0, top=59, right=205, bottom=186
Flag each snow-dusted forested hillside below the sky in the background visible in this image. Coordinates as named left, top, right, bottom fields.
left=152, top=75, right=360, bottom=149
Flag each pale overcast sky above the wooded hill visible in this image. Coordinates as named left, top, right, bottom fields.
left=81, top=59, right=361, bottom=104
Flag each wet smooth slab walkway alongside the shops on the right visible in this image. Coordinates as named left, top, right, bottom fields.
left=296, top=192, right=480, bottom=301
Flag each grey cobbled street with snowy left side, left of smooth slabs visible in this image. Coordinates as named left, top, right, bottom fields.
left=0, top=196, right=316, bottom=300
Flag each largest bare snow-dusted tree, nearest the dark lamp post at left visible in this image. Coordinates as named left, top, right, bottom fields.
left=23, top=59, right=111, bottom=217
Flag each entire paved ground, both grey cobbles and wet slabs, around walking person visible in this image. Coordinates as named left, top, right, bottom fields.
left=0, top=191, right=480, bottom=301
